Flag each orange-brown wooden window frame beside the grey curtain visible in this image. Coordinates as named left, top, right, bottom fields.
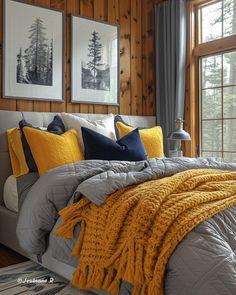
left=184, top=0, right=236, bottom=157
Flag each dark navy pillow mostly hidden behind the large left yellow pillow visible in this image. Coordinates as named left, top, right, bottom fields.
left=19, top=115, right=65, bottom=172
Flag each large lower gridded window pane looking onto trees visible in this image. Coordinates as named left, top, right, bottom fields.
left=199, top=51, right=236, bottom=162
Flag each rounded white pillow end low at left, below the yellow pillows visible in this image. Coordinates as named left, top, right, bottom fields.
left=3, top=175, right=18, bottom=212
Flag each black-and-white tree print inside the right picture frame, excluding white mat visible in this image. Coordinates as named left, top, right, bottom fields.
left=81, top=30, right=110, bottom=91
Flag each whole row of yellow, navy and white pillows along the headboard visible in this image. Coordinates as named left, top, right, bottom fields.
left=7, top=113, right=164, bottom=176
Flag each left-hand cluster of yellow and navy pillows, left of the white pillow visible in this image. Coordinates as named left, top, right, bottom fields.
left=7, top=116, right=84, bottom=177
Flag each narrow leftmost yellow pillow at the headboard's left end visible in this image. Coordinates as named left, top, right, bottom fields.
left=7, top=128, right=29, bottom=177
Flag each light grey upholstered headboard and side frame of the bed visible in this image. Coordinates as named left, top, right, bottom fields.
left=0, top=111, right=156, bottom=279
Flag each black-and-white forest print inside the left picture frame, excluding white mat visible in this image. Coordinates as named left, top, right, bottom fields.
left=16, top=17, right=53, bottom=86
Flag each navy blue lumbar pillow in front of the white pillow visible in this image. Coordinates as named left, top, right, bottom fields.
left=81, top=127, right=147, bottom=161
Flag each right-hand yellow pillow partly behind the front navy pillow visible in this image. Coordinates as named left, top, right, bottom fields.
left=116, top=121, right=164, bottom=159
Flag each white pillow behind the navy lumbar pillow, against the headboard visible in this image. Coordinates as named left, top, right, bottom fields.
left=61, top=113, right=116, bottom=150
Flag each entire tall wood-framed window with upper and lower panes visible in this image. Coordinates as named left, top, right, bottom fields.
left=186, top=0, right=236, bottom=162
